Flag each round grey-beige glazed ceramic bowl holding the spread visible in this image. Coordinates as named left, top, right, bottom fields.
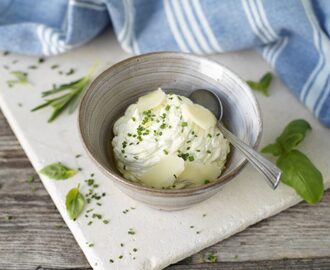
left=78, top=52, right=262, bottom=210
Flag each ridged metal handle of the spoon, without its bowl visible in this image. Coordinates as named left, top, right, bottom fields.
left=218, top=121, right=282, bottom=189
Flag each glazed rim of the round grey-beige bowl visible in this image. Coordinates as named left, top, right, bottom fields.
left=77, top=51, right=263, bottom=197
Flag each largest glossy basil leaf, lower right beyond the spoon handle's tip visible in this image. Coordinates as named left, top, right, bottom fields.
left=276, top=150, right=324, bottom=204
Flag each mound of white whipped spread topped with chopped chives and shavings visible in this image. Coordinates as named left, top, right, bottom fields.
left=112, top=89, right=230, bottom=188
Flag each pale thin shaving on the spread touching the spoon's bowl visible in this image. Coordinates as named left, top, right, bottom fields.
left=182, top=104, right=217, bottom=130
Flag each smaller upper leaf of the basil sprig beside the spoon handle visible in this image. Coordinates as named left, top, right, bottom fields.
left=276, top=119, right=312, bottom=152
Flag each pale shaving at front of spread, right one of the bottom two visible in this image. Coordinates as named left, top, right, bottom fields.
left=178, top=161, right=221, bottom=185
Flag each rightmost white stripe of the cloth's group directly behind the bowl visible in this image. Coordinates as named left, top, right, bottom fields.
left=191, top=0, right=223, bottom=52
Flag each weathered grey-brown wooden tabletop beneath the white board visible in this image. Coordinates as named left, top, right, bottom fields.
left=0, top=108, right=330, bottom=270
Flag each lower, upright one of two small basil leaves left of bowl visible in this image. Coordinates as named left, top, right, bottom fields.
left=65, top=185, right=85, bottom=220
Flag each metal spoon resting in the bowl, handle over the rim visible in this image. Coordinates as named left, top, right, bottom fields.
left=189, top=89, right=282, bottom=189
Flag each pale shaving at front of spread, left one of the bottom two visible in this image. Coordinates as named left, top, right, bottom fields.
left=140, top=155, right=184, bottom=188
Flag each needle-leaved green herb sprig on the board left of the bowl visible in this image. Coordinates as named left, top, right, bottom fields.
left=32, top=65, right=96, bottom=123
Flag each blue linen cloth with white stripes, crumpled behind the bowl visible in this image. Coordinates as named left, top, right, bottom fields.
left=0, top=0, right=330, bottom=127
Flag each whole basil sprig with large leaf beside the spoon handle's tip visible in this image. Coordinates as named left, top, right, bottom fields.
left=261, top=119, right=324, bottom=204
